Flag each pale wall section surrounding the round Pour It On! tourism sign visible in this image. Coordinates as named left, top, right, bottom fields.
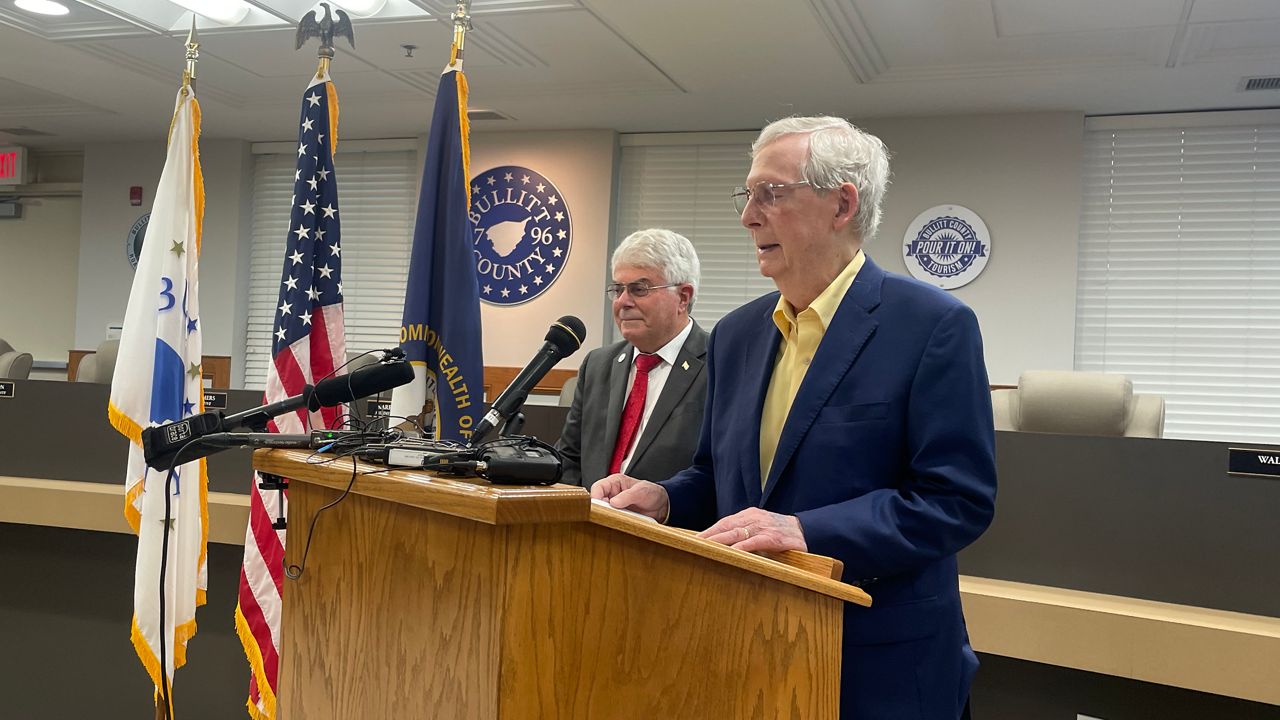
left=861, top=113, right=1084, bottom=384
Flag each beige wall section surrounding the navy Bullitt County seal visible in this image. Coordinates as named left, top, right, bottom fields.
left=471, top=131, right=616, bottom=370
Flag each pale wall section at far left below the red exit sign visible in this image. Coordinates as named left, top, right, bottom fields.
left=0, top=197, right=80, bottom=358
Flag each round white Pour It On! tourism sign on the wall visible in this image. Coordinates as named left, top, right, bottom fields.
left=902, top=205, right=991, bottom=290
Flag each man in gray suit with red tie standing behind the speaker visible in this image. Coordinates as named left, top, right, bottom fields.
left=557, top=229, right=707, bottom=488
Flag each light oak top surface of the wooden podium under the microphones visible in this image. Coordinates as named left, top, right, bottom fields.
left=253, top=450, right=872, bottom=606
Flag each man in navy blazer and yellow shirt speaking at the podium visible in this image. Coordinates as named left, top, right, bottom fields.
left=591, top=118, right=996, bottom=720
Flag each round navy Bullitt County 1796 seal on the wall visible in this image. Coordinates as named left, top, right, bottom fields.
left=471, top=165, right=572, bottom=305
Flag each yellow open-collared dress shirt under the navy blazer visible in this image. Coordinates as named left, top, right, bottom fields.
left=760, top=250, right=867, bottom=488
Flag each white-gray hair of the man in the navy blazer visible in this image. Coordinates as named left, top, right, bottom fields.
left=751, top=117, right=888, bottom=242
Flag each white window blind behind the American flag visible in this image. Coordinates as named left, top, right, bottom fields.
left=244, top=149, right=420, bottom=388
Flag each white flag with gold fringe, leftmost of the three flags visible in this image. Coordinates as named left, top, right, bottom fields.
left=108, top=85, right=209, bottom=715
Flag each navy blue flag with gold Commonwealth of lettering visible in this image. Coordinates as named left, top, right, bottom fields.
left=390, top=45, right=484, bottom=441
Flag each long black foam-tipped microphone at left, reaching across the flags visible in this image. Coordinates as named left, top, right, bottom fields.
left=142, top=360, right=413, bottom=470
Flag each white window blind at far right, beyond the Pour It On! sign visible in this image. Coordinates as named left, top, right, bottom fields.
left=1075, top=122, right=1280, bottom=443
